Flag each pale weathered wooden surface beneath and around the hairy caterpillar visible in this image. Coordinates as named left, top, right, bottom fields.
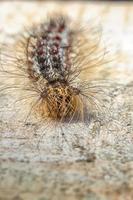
left=0, top=1, right=133, bottom=200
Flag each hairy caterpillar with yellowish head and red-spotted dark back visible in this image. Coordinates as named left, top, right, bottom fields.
left=0, top=16, right=112, bottom=128
